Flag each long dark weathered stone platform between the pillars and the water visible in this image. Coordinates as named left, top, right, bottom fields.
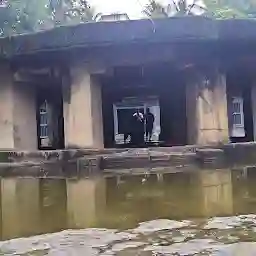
left=0, top=142, right=256, bottom=177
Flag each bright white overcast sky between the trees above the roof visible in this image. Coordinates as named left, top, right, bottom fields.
left=89, top=0, right=204, bottom=19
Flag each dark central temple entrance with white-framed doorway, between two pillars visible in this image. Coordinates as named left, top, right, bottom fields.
left=101, top=63, right=187, bottom=148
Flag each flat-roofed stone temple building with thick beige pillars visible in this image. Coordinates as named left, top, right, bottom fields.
left=0, top=17, right=256, bottom=150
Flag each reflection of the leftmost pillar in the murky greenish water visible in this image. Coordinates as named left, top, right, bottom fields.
left=1, top=179, right=41, bottom=239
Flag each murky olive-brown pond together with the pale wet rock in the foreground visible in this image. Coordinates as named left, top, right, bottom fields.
left=0, top=168, right=256, bottom=256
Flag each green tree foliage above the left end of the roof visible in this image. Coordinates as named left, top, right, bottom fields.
left=0, top=0, right=93, bottom=36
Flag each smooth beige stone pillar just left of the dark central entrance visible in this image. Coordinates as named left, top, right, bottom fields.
left=63, top=66, right=104, bottom=148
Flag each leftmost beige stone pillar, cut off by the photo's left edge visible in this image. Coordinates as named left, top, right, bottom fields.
left=0, top=64, right=38, bottom=150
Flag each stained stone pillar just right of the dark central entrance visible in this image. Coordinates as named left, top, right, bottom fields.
left=186, top=70, right=229, bottom=145
